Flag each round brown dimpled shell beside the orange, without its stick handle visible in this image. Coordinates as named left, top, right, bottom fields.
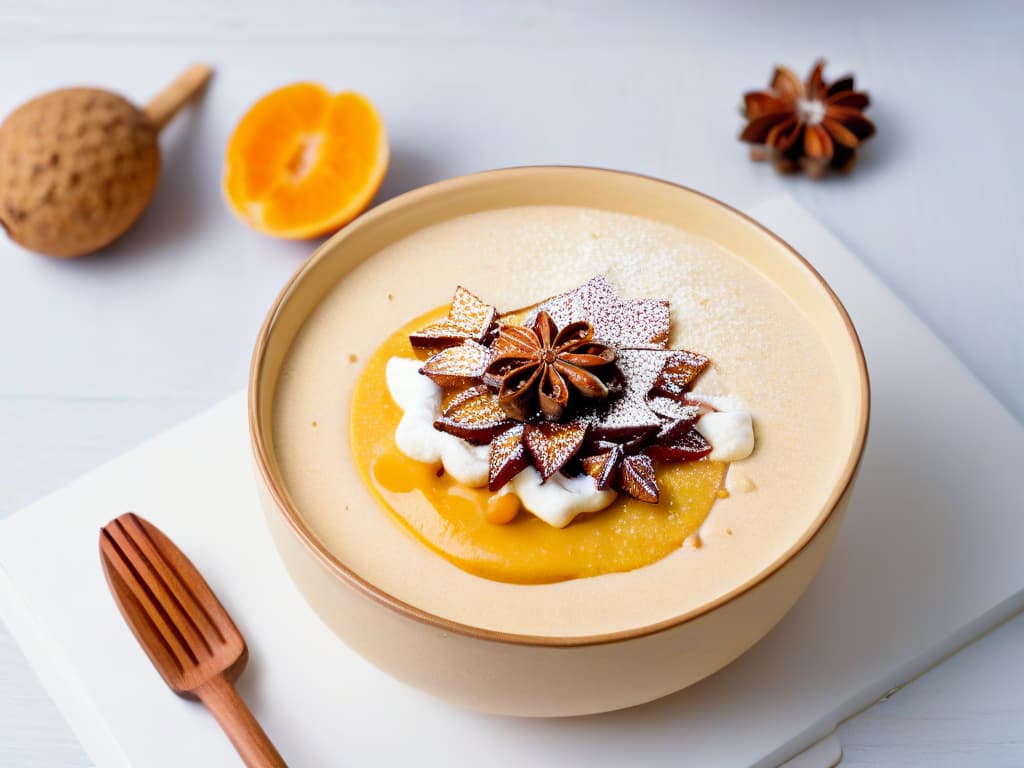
left=0, top=88, right=160, bottom=258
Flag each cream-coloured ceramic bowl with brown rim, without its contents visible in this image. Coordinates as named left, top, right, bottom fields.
left=249, top=167, right=868, bottom=716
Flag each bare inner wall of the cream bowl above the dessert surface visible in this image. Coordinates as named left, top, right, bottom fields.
left=250, top=167, right=868, bottom=633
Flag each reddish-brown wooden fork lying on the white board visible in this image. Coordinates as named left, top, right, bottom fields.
left=99, top=512, right=285, bottom=768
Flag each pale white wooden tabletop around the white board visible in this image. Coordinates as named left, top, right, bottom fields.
left=0, top=0, right=1024, bottom=768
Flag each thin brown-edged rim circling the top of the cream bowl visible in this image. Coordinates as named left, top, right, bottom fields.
left=248, top=165, right=870, bottom=647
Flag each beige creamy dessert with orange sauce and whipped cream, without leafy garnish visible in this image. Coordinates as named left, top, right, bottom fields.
left=273, top=207, right=843, bottom=635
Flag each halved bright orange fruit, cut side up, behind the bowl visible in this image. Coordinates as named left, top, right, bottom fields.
left=224, top=83, right=388, bottom=240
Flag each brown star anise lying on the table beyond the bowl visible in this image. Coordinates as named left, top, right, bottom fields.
left=739, top=59, right=874, bottom=177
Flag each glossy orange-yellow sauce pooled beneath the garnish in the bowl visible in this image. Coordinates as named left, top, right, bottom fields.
left=351, top=306, right=727, bottom=584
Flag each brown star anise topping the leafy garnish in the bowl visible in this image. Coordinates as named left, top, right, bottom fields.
left=483, top=310, right=615, bottom=421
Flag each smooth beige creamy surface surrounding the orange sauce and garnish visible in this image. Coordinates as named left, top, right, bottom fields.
left=271, top=206, right=852, bottom=636
